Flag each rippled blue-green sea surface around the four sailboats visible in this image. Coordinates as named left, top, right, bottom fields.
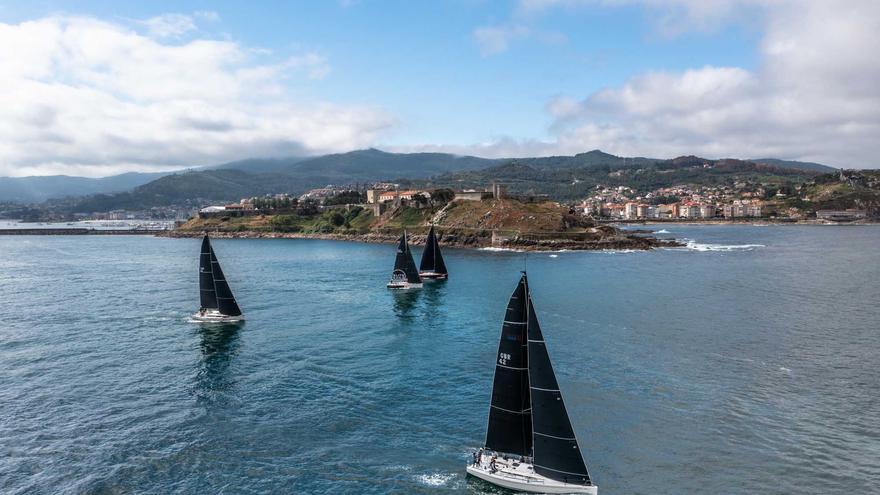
left=0, top=225, right=880, bottom=494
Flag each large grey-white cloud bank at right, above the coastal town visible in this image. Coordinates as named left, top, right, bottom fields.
left=458, top=0, right=880, bottom=168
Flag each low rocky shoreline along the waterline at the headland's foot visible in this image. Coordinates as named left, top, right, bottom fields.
left=158, top=230, right=684, bottom=251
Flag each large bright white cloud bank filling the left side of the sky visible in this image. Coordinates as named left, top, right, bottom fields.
left=0, top=15, right=395, bottom=175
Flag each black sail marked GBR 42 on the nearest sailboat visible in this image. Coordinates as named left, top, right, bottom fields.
left=486, top=275, right=532, bottom=456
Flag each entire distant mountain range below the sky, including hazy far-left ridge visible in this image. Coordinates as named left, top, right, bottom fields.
left=0, top=149, right=836, bottom=207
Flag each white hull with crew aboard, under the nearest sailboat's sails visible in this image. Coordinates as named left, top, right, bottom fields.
left=467, top=455, right=599, bottom=495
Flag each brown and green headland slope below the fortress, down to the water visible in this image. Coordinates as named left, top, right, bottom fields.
left=169, top=199, right=678, bottom=251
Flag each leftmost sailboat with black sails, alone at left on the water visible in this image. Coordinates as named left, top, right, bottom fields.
left=192, top=234, right=244, bottom=323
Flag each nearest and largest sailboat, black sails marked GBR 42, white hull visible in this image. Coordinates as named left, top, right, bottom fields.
left=467, top=272, right=598, bottom=495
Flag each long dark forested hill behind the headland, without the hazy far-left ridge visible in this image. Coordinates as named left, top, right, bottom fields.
left=55, top=149, right=840, bottom=212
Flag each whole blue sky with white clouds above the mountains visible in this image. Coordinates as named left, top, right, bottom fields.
left=0, top=0, right=880, bottom=177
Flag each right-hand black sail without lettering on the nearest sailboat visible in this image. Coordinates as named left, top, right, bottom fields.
left=527, top=280, right=590, bottom=484
